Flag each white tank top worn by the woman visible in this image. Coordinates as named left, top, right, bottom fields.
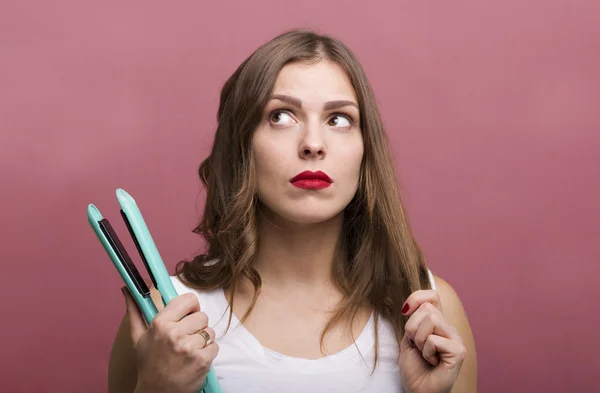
left=171, top=271, right=435, bottom=393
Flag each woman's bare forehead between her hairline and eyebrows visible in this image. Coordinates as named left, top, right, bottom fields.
left=273, top=60, right=357, bottom=104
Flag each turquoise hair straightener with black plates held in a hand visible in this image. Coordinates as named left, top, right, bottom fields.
left=87, top=189, right=221, bottom=393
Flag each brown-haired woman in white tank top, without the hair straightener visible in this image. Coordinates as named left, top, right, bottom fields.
left=109, top=31, right=476, bottom=393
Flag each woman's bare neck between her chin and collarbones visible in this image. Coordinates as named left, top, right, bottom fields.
left=254, top=205, right=344, bottom=289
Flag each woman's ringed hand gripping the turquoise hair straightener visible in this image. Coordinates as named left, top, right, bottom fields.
left=123, top=287, right=219, bottom=393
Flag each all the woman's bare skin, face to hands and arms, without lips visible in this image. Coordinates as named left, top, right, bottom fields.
left=109, top=61, right=477, bottom=393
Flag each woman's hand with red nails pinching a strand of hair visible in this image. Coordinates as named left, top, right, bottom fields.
left=400, top=290, right=466, bottom=393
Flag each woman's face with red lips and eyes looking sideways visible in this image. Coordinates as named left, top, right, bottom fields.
left=252, top=61, right=363, bottom=224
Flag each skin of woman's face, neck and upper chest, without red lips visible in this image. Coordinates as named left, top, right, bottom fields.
left=225, top=62, right=370, bottom=359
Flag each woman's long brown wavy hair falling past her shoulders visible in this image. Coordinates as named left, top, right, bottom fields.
left=176, top=30, right=431, bottom=367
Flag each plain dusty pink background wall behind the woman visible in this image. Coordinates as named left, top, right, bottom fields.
left=0, top=0, right=600, bottom=393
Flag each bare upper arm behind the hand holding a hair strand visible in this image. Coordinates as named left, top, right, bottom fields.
left=434, top=276, right=477, bottom=393
